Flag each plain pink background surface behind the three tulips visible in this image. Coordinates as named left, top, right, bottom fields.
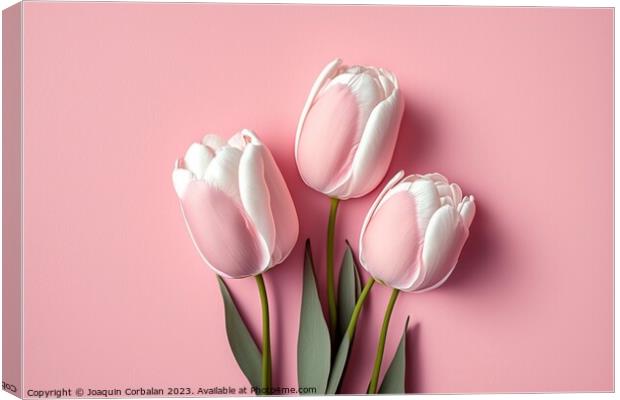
left=18, top=2, right=613, bottom=392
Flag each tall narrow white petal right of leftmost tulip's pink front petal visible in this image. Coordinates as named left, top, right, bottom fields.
left=239, top=144, right=276, bottom=260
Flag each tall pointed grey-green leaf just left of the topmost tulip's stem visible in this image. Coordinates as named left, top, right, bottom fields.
left=297, top=240, right=331, bottom=395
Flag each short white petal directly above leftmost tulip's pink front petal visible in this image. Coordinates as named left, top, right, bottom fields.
left=204, top=146, right=241, bottom=198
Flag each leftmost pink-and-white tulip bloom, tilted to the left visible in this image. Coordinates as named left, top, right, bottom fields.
left=172, top=130, right=299, bottom=278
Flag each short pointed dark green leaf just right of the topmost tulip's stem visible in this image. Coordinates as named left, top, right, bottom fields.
left=337, top=242, right=362, bottom=340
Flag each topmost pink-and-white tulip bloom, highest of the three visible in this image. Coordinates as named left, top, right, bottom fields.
left=295, top=59, right=404, bottom=200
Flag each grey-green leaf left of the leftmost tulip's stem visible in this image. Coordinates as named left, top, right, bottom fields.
left=217, top=276, right=261, bottom=387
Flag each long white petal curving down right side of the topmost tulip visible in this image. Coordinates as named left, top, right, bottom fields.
left=340, top=88, right=404, bottom=199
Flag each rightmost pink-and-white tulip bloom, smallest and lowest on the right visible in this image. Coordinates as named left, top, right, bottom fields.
left=359, top=171, right=476, bottom=292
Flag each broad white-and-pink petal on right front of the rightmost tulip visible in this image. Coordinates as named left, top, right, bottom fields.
left=414, top=205, right=469, bottom=292
